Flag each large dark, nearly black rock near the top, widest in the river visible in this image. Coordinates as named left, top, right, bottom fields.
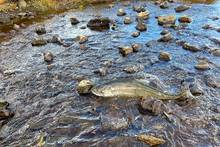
left=87, top=17, right=111, bottom=30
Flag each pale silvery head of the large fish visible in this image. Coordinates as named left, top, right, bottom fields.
left=91, top=85, right=114, bottom=97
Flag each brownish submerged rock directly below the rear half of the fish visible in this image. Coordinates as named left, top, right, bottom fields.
left=140, top=98, right=166, bottom=115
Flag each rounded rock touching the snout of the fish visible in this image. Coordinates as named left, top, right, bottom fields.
left=76, top=80, right=93, bottom=95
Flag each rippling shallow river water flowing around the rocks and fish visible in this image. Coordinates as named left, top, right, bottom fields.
left=0, top=1, right=220, bottom=147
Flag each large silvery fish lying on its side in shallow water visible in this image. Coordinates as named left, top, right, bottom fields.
left=91, top=79, right=192, bottom=100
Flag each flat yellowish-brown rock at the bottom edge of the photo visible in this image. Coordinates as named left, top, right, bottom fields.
left=137, top=134, right=166, bottom=146
